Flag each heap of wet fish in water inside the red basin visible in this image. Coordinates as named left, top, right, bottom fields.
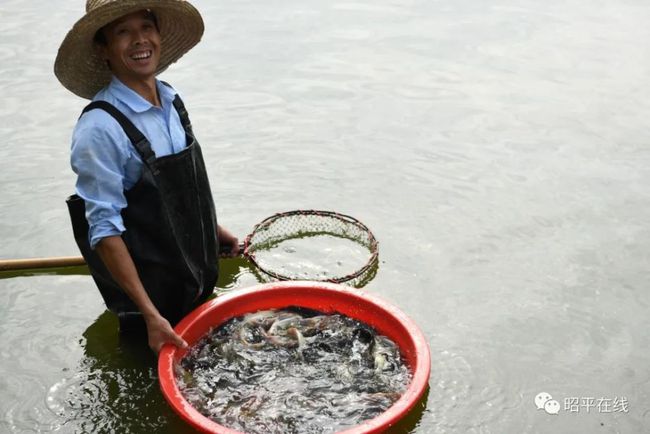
left=175, top=307, right=411, bottom=434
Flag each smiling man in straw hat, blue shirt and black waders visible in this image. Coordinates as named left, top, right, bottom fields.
left=54, top=0, right=238, bottom=352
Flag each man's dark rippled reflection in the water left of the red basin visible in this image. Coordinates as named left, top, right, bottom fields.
left=47, top=312, right=197, bottom=433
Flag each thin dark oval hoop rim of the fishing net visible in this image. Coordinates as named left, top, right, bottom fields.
left=244, top=210, right=379, bottom=283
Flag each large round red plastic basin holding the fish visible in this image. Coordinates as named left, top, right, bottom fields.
left=158, top=282, right=431, bottom=434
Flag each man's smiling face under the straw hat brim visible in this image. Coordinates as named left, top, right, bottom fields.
left=100, top=11, right=160, bottom=85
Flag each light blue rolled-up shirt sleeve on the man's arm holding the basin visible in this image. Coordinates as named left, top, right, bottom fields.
left=70, top=110, right=129, bottom=249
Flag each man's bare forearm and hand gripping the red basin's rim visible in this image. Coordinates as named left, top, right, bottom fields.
left=96, top=236, right=187, bottom=354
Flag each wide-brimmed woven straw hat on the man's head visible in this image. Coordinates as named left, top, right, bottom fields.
left=54, top=0, right=203, bottom=99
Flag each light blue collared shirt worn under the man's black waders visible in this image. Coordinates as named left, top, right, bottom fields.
left=70, top=77, right=186, bottom=248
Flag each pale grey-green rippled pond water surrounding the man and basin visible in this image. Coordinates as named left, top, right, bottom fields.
left=0, top=0, right=650, bottom=434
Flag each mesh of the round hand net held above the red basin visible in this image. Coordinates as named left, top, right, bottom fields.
left=245, top=210, right=378, bottom=287
